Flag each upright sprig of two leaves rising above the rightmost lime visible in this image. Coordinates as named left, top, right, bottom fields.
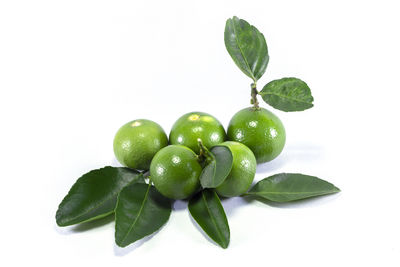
left=224, top=17, right=314, bottom=111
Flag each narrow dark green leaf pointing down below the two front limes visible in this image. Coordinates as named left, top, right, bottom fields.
left=189, top=189, right=230, bottom=248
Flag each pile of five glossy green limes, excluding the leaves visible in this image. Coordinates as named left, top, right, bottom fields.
left=114, top=107, right=285, bottom=199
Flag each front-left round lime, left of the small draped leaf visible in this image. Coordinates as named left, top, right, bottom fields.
left=150, top=145, right=202, bottom=199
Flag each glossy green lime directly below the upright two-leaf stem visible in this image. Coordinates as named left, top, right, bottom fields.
left=228, top=108, right=286, bottom=163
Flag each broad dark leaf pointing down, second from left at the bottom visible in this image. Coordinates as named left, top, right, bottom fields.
left=115, top=184, right=171, bottom=247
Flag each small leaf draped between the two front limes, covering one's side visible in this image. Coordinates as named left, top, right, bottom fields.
left=200, top=146, right=233, bottom=188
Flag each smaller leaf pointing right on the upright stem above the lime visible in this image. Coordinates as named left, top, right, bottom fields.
left=259, top=78, right=314, bottom=111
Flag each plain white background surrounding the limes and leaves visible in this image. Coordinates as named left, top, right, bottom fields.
left=0, top=0, right=400, bottom=266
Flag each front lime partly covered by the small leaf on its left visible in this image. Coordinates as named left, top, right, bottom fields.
left=216, top=141, right=257, bottom=197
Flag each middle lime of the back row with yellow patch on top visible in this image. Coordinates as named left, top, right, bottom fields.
left=169, top=112, right=226, bottom=154
